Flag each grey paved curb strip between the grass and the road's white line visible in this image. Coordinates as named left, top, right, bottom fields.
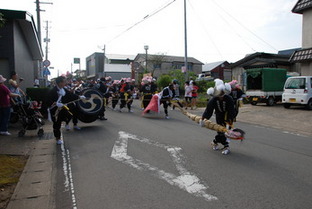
left=7, top=126, right=56, bottom=209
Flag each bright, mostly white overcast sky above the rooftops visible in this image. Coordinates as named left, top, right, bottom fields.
left=0, top=0, right=302, bottom=76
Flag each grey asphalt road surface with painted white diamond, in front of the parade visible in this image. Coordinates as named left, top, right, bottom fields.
left=56, top=100, right=312, bottom=209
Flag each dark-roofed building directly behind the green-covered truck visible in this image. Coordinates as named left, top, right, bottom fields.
left=229, top=49, right=297, bottom=86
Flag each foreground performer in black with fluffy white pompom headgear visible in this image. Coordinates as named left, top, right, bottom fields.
left=202, top=79, right=235, bottom=155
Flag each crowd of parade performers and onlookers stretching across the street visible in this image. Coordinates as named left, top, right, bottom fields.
left=0, top=72, right=244, bottom=154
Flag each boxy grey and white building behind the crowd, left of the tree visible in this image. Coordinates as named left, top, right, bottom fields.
left=86, top=52, right=135, bottom=80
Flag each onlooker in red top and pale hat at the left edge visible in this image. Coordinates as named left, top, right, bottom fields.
left=0, top=75, right=20, bottom=136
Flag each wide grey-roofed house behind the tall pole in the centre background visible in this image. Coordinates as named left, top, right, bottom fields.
left=133, top=54, right=203, bottom=77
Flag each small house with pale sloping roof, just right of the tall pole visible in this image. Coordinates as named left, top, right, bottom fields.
left=202, top=61, right=232, bottom=80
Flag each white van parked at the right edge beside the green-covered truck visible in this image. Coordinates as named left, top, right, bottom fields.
left=282, top=76, right=312, bottom=110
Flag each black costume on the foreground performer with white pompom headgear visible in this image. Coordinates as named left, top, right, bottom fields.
left=202, top=95, right=235, bottom=147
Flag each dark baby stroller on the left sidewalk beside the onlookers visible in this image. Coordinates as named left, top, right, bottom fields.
left=11, top=96, right=44, bottom=137
